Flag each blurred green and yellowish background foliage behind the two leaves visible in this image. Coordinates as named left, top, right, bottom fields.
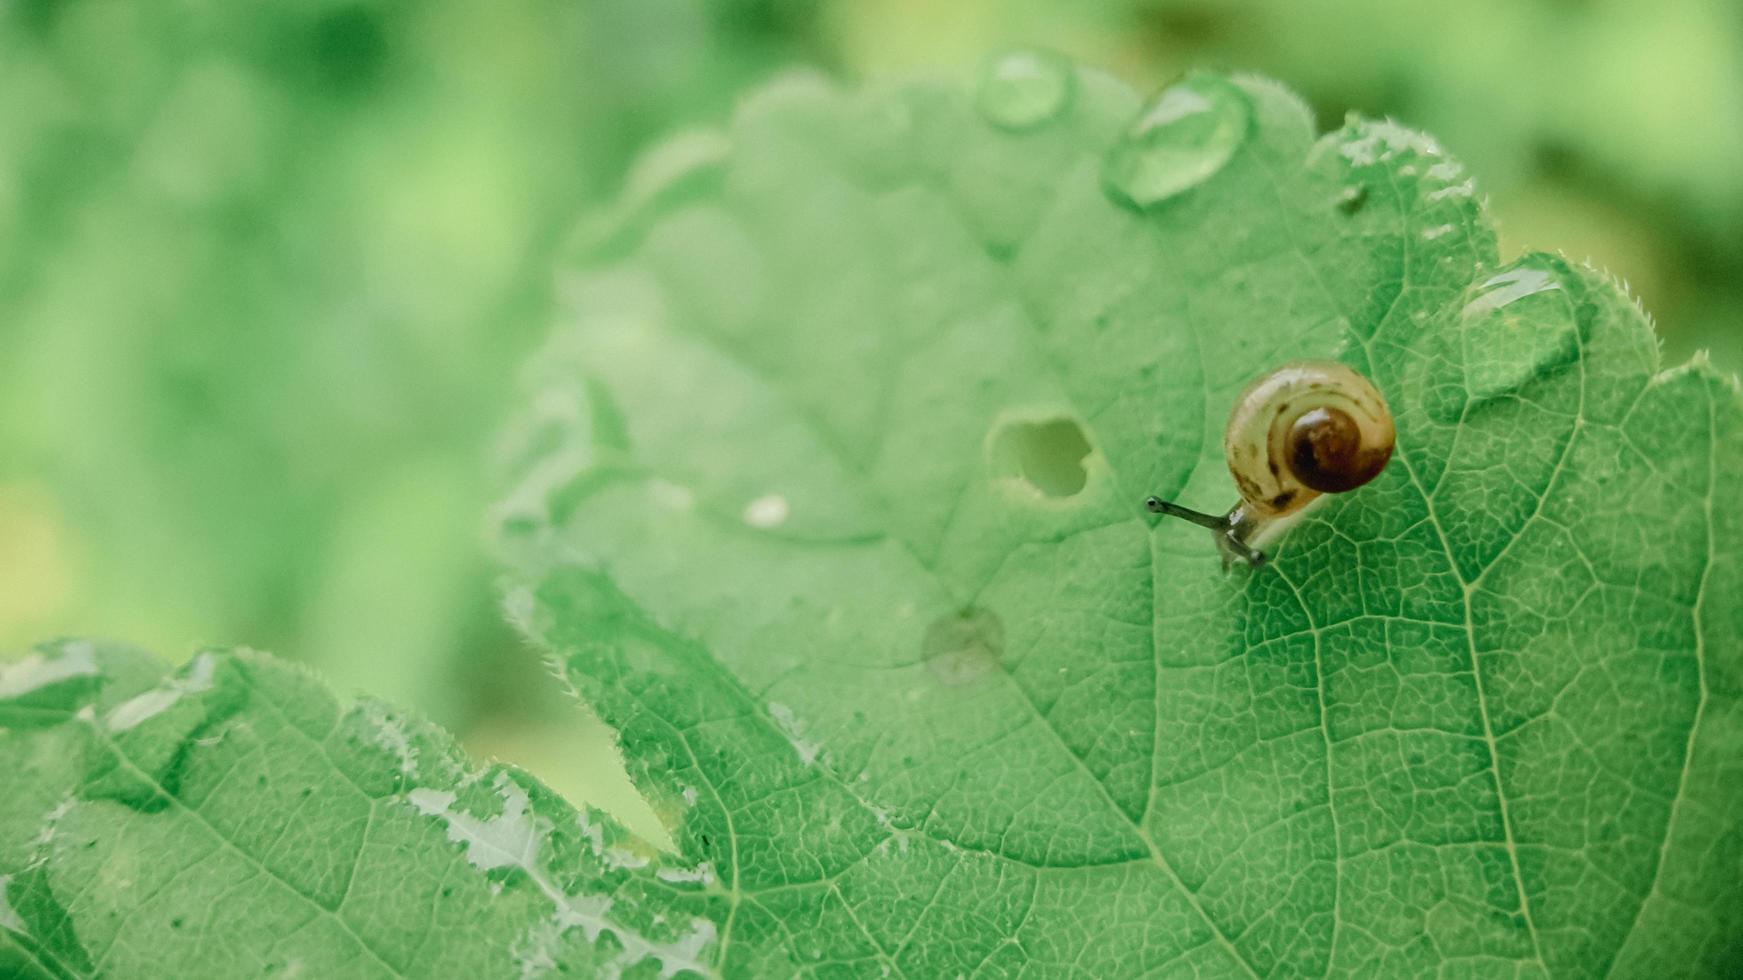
left=0, top=0, right=1743, bottom=804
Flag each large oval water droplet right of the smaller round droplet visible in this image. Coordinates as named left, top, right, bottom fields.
left=1102, top=75, right=1253, bottom=208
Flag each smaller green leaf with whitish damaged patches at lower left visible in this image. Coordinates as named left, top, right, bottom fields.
left=0, top=642, right=716, bottom=978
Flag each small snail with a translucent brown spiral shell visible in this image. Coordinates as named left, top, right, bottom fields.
left=1143, top=361, right=1396, bottom=568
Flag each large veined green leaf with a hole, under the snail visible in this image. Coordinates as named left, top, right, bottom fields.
left=498, top=64, right=1743, bottom=977
